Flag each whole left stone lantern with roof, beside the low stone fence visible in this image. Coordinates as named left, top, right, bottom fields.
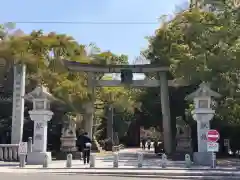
left=25, top=86, right=54, bottom=164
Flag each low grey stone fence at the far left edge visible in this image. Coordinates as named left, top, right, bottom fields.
left=0, top=144, right=19, bottom=161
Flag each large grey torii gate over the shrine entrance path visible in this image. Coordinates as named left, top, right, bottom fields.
left=64, top=60, right=173, bottom=153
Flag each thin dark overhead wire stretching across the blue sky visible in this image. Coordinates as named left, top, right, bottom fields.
left=7, top=21, right=159, bottom=25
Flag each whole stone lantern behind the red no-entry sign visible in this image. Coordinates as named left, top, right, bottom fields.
left=186, top=82, right=221, bottom=165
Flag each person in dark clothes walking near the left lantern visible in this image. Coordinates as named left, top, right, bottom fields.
left=81, top=132, right=92, bottom=164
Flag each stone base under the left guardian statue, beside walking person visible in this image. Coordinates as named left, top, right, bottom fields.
left=61, top=136, right=77, bottom=152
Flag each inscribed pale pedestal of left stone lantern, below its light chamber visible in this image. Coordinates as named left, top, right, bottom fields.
left=27, top=110, right=53, bottom=165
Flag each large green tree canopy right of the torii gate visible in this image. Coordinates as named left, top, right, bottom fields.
left=143, top=0, right=240, bottom=124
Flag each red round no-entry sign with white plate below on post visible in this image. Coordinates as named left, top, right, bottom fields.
left=207, top=129, right=220, bottom=168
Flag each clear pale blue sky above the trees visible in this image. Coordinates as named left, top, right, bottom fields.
left=0, top=0, right=186, bottom=61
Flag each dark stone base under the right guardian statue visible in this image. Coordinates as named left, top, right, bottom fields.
left=176, top=137, right=193, bottom=153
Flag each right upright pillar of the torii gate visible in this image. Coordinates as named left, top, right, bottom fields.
left=159, top=72, right=172, bottom=154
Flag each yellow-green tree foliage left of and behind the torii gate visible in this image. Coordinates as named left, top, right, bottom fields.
left=0, top=23, right=139, bottom=142
